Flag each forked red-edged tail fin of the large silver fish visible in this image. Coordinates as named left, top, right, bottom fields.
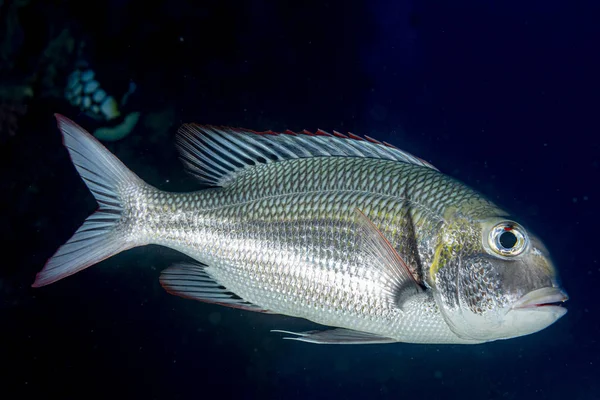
left=32, top=114, right=145, bottom=287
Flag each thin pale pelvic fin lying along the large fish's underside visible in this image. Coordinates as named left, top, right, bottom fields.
left=271, top=328, right=397, bottom=344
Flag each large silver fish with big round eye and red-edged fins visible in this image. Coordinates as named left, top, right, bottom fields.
left=32, top=114, right=568, bottom=344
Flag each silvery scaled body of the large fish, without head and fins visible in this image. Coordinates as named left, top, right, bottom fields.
left=124, top=158, right=486, bottom=341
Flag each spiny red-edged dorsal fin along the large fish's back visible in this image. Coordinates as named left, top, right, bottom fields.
left=177, top=124, right=437, bottom=186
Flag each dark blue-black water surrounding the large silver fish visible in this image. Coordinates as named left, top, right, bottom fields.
left=0, top=0, right=600, bottom=399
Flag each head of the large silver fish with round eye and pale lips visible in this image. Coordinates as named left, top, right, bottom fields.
left=433, top=217, right=568, bottom=342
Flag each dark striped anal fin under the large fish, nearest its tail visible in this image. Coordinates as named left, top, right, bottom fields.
left=160, top=263, right=271, bottom=313
